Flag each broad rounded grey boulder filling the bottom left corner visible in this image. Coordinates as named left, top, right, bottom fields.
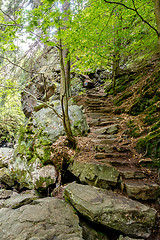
left=0, top=195, right=83, bottom=240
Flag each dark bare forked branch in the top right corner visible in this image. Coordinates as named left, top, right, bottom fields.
left=104, top=0, right=159, bottom=35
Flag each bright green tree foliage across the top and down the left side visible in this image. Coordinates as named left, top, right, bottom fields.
left=0, top=0, right=160, bottom=144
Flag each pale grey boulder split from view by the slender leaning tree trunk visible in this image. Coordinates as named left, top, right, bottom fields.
left=33, top=100, right=89, bottom=142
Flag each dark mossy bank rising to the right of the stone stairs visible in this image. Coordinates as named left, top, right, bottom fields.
left=105, top=58, right=160, bottom=167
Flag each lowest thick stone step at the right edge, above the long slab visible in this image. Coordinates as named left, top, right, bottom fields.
left=121, top=179, right=160, bottom=201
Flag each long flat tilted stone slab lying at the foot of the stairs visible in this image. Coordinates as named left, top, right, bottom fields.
left=65, top=183, right=156, bottom=238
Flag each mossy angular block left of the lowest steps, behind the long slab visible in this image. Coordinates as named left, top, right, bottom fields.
left=68, top=161, right=119, bottom=188
